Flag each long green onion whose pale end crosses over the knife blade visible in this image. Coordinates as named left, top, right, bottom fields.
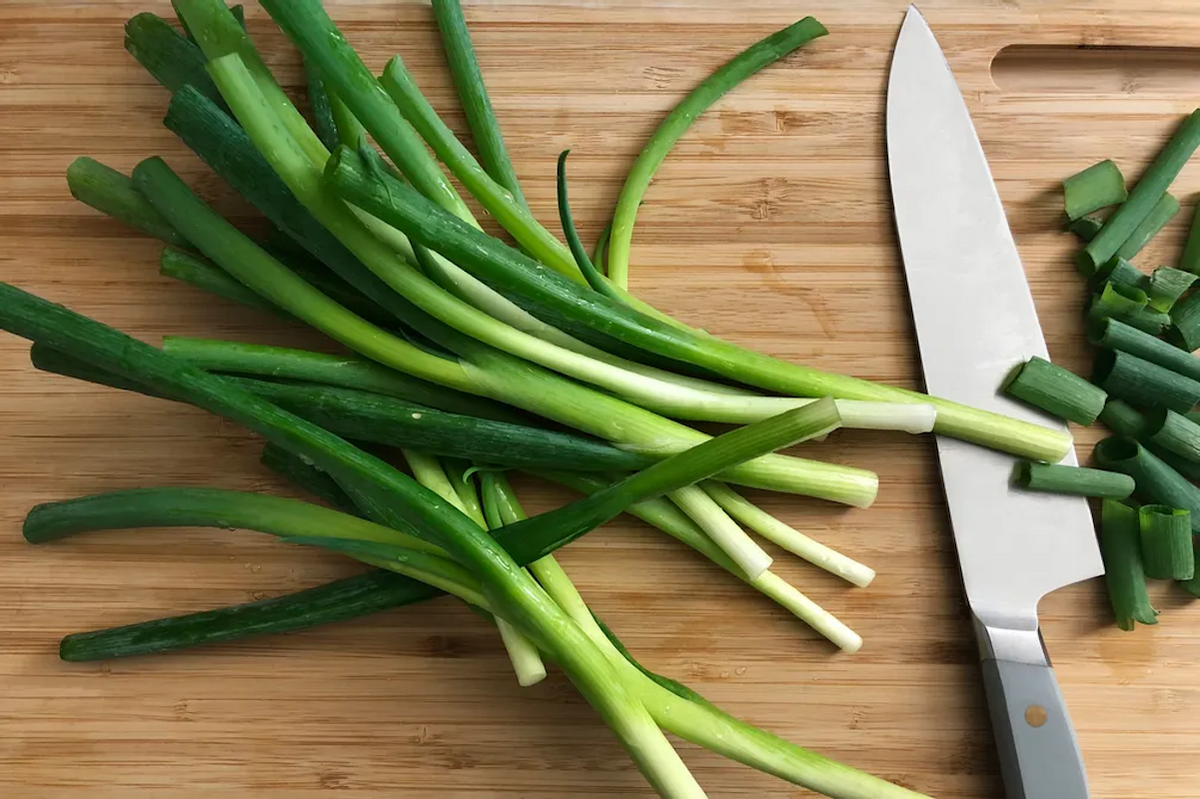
left=326, top=148, right=1068, bottom=461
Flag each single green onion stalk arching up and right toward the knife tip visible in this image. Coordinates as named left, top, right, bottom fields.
left=608, top=17, right=829, bottom=288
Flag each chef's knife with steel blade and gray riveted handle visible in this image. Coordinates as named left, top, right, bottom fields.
left=887, top=7, right=1104, bottom=799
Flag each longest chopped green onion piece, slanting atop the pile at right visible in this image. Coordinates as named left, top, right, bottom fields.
left=1079, top=112, right=1200, bottom=274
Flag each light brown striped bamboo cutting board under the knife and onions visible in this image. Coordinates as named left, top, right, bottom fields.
left=0, top=0, right=1200, bottom=799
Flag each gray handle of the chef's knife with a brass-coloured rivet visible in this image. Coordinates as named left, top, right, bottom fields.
left=983, top=659, right=1090, bottom=799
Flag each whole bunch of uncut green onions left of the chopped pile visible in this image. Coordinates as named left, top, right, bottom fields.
left=0, top=0, right=1070, bottom=799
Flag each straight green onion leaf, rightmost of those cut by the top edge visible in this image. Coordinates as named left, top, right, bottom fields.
left=432, top=0, right=529, bottom=208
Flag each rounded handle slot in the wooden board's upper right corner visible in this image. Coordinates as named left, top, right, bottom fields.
left=991, top=44, right=1200, bottom=96
